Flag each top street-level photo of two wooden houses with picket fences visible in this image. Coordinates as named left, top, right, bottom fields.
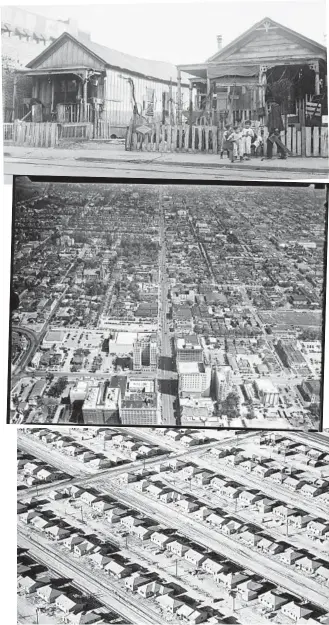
left=1, top=0, right=328, bottom=180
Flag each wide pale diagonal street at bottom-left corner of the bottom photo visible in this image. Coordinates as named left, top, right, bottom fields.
left=18, top=527, right=167, bottom=625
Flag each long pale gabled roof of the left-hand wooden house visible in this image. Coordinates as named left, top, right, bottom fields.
left=26, top=32, right=187, bottom=83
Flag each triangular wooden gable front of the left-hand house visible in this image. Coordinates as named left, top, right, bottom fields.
left=33, top=40, right=104, bottom=70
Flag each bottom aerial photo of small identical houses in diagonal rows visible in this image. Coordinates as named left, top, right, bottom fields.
left=17, top=426, right=329, bottom=625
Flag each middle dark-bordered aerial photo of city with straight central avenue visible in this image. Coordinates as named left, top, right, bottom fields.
left=8, top=177, right=326, bottom=430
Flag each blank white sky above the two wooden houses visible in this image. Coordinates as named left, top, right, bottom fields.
left=24, top=0, right=326, bottom=64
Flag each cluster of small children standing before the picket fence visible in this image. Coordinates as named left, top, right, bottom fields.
left=221, top=120, right=262, bottom=163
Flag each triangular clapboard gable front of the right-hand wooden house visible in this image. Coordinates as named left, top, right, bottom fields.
left=218, top=30, right=318, bottom=64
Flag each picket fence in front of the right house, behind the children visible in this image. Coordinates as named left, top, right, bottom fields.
left=126, top=123, right=328, bottom=157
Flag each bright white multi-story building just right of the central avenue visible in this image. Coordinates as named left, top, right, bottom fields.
left=177, top=362, right=211, bottom=397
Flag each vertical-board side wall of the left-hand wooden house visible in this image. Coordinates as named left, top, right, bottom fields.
left=102, top=69, right=189, bottom=127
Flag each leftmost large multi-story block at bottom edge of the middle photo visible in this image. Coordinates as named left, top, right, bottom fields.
left=82, top=381, right=121, bottom=425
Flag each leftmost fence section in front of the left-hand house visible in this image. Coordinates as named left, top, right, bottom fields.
left=13, top=122, right=58, bottom=148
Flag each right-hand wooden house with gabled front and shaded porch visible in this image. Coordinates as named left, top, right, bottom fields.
left=177, top=17, right=327, bottom=127
